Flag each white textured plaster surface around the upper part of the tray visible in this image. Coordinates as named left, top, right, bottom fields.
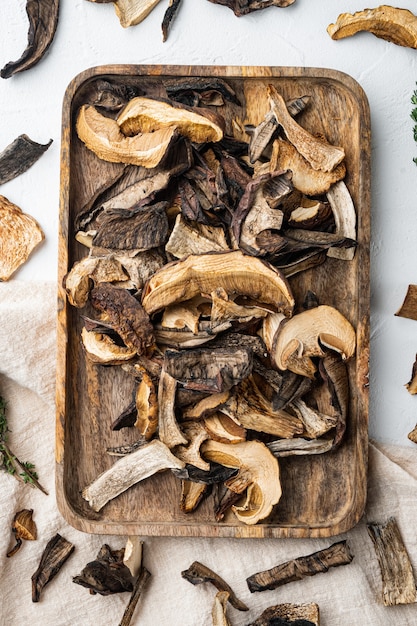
left=0, top=0, right=417, bottom=446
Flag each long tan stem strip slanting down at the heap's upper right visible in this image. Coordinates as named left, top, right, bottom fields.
left=268, top=85, right=345, bottom=172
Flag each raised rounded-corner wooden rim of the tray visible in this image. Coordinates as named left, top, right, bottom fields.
left=55, top=64, right=371, bottom=538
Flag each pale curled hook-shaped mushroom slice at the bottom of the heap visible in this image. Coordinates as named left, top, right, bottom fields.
left=201, top=440, right=282, bottom=525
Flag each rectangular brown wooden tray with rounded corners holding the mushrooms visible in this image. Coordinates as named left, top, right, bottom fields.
left=56, top=65, right=370, bottom=537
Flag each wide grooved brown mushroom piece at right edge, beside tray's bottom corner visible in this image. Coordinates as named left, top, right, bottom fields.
left=367, top=517, right=417, bottom=606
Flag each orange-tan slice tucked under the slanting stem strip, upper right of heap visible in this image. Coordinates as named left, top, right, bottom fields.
left=270, top=139, right=346, bottom=196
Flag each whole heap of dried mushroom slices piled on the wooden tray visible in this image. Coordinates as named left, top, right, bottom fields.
left=64, top=77, right=356, bottom=524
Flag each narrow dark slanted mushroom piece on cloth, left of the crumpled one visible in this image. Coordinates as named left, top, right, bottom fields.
left=32, top=533, right=75, bottom=602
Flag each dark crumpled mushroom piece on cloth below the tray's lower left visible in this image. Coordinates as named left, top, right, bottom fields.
left=72, top=544, right=134, bottom=596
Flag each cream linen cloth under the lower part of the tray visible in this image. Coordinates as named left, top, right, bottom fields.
left=0, top=280, right=417, bottom=626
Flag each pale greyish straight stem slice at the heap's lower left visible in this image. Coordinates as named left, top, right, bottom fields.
left=82, top=439, right=185, bottom=512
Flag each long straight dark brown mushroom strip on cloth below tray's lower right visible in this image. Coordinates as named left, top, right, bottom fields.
left=246, top=541, right=353, bottom=593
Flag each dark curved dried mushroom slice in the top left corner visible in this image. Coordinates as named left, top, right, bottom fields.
left=0, top=0, right=59, bottom=78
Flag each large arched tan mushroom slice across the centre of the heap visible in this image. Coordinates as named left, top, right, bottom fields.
left=142, top=250, right=294, bottom=315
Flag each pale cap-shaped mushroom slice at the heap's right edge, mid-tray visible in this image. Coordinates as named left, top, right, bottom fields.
left=271, top=304, right=356, bottom=378
